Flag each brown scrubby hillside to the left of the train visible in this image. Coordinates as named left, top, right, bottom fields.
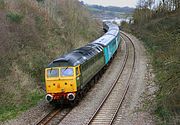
left=0, top=0, right=102, bottom=121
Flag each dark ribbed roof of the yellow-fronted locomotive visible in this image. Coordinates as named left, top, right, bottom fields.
left=48, top=44, right=103, bottom=67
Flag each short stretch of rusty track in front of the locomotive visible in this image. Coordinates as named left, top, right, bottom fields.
left=36, top=108, right=71, bottom=125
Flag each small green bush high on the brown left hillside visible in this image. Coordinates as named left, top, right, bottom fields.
left=6, top=12, right=24, bottom=23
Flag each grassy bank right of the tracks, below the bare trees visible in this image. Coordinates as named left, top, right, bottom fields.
left=131, top=10, right=180, bottom=125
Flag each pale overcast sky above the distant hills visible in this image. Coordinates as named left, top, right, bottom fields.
left=79, top=0, right=138, bottom=8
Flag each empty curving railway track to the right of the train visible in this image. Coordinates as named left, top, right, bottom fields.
left=87, top=32, right=136, bottom=125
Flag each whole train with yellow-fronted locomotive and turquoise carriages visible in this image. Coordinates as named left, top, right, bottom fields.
left=45, top=22, right=121, bottom=105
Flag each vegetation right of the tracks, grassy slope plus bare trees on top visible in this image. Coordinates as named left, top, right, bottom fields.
left=129, top=0, right=180, bottom=125
